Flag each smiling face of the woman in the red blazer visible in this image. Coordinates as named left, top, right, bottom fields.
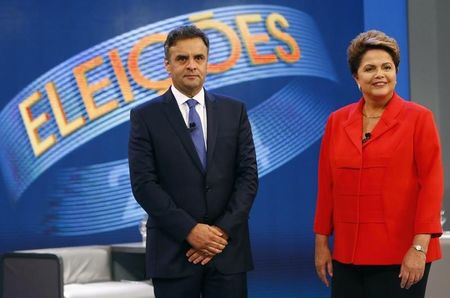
left=354, top=49, right=397, bottom=101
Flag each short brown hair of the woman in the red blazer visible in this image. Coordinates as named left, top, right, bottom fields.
left=347, top=30, right=400, bottom=75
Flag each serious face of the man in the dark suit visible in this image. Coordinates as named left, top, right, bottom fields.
left=165, top=38, right=208, bottom=97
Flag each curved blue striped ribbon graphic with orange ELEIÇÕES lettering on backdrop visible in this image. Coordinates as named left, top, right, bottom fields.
left=0, top=5, right=337, bottom=236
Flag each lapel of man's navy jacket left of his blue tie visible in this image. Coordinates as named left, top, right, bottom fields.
left=163, top=89, right=204, bottom=173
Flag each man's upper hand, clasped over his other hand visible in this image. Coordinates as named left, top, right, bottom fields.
left=186, top=224, right=228, bottom=256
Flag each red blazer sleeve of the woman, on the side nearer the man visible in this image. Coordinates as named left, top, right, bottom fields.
left=314, top=115, right=333, bottom=235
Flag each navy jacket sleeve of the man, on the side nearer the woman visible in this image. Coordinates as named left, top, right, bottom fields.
left=215, top=104, right=258, bottom=238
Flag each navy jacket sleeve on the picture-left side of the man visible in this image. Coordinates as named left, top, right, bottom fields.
left=128, top=110, right=197, bottom=242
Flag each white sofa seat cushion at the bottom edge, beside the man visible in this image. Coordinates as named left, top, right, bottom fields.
left=64, top=281, right=155, bottom=298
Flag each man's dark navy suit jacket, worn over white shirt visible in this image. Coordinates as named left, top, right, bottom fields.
left=128, top=89, right=258, bottom=277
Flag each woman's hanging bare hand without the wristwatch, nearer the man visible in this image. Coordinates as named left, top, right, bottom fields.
left=315, top=234, right=333, bottom=287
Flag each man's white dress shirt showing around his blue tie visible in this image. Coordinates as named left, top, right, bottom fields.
left=170, top=85, right=207, bottom=148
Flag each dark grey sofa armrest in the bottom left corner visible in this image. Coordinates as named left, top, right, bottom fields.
left=0, top=253, right=64, bottom=298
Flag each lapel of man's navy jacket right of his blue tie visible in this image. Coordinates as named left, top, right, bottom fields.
left=205, top=91, right=218, bottom=169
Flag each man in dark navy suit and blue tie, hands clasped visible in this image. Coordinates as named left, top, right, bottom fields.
left=129, top=26, right=258, bottom=298
